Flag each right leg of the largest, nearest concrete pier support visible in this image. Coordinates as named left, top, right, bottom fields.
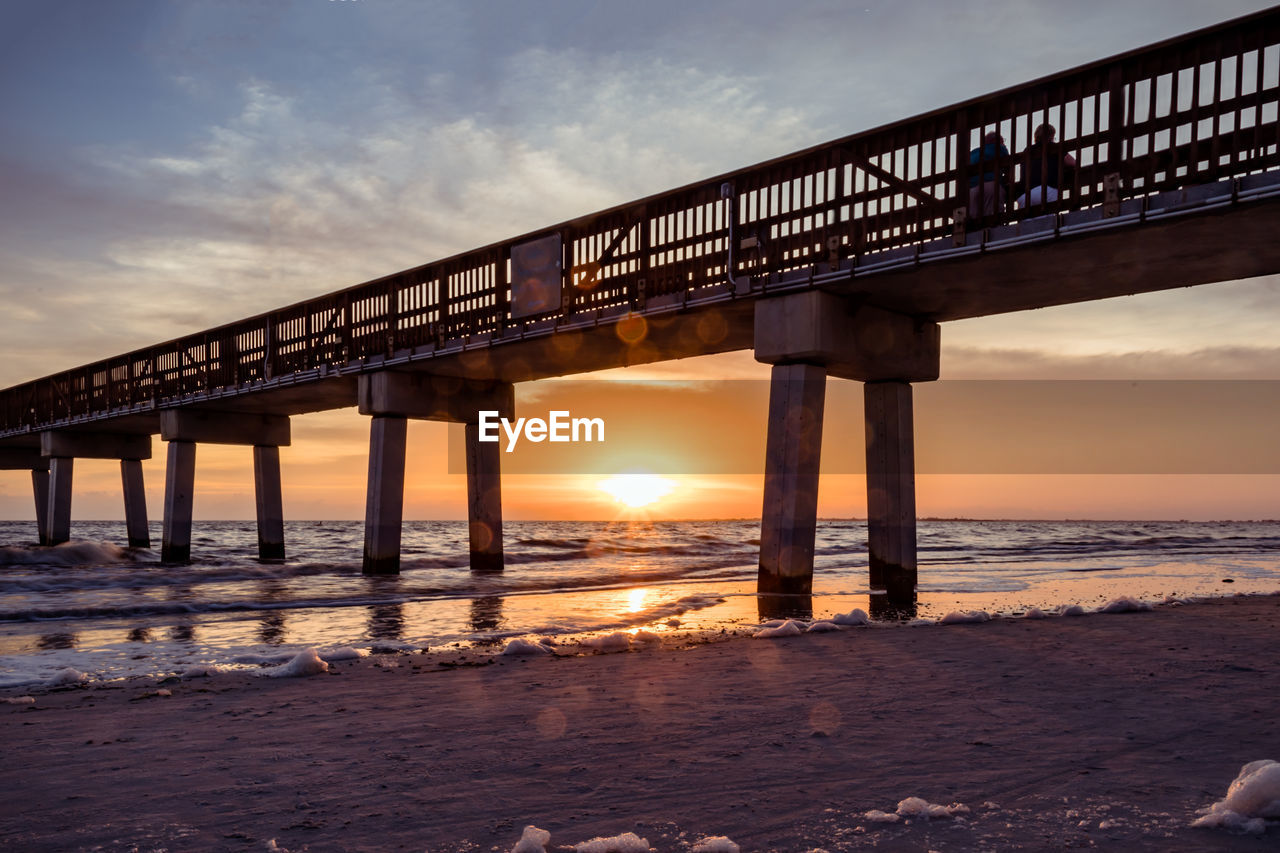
left=864, top=382, right=916, bottom=608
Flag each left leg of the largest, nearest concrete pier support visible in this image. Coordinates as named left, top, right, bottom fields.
left=758, top=364, right=827, bottom=594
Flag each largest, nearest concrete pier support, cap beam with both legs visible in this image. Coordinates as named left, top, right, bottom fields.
left=754, top=291, right=941, bottom=604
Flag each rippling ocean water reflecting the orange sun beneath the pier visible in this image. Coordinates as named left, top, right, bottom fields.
left=0, top=520, right=1280, bottom=690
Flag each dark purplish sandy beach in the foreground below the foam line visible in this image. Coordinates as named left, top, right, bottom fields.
left=0, top=596, right=1280, bottom=853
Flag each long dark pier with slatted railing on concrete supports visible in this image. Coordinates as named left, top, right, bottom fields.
left=0, top=9, right=1280, bottom=608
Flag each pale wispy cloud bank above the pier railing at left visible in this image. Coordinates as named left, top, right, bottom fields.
left=0, top=49, right=804, bottom=382
